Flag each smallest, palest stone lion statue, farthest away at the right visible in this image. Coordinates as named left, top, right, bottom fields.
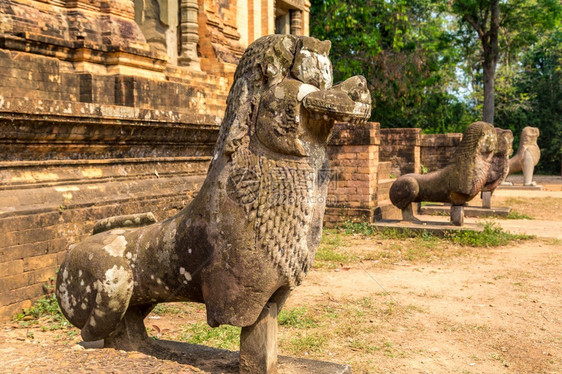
left=509, top=126, right=541, bottom=186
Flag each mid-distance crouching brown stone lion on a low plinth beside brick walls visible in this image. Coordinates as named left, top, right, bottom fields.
left=390, top=122, right=497, bottom=223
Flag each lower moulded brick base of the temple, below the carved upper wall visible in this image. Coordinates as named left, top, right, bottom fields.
left=0, top=49, right=226, bottom=319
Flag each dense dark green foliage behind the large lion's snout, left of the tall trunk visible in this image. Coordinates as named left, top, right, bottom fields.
left=310, top=0, right=472, bottom=131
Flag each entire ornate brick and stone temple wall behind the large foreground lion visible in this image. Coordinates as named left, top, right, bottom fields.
left=0, top=0, right=309, bottom=319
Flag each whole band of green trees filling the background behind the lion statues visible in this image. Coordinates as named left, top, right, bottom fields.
left=310, top=0, right=562, bottom=171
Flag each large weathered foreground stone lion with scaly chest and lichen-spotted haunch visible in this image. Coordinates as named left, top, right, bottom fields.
left=56, top=35, right=370, bottom=349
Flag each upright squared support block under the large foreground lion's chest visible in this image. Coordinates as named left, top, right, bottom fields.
left=240, top=303, right=278, bottom=374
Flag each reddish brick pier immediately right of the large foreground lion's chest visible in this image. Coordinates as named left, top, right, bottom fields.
left=324, top=122, right=380, bottom=227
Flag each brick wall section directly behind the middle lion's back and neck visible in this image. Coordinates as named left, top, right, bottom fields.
left=421, top=133, right=462, bottom=171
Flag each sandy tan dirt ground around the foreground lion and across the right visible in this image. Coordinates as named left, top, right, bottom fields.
left=0, top=177, right=562, bottom=373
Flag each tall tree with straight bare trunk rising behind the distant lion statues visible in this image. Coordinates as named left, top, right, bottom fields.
left=447, top=0, right=562, bottom=123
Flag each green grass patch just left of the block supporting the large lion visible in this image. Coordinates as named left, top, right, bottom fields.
left=179, top=322, right=241, bottom=350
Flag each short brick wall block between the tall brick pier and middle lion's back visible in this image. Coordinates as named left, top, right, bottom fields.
left=380, top=128, right=422, bottom=177
